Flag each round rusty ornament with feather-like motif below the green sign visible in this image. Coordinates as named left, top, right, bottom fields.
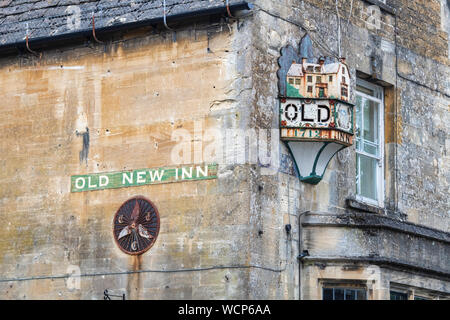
left=113, top=196, right=159, bottom=255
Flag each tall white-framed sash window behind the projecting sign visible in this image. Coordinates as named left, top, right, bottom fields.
left=355, top=79, right=384, bottom=207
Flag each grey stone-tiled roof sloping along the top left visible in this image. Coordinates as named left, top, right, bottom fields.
left=0, top=0, right=247, bottom=47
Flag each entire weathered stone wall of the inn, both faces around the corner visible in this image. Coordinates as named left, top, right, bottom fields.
left=0, top=0, right=450, bottom=299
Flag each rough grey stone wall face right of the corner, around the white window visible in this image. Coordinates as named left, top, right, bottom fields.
left=246, top=0, right=450, bottom=298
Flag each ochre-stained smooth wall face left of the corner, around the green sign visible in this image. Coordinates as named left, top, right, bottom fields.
left=0, top=25, right=264, bottom=299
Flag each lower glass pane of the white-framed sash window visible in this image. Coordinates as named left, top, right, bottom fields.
left=356, top=154, right=377, bottom=200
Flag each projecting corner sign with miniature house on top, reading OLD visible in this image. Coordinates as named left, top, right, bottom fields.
left=278, top=38, right=354, bottom=184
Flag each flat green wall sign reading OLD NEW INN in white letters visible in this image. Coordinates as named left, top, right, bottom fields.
left=70, top=164, right=217, bottom=192
